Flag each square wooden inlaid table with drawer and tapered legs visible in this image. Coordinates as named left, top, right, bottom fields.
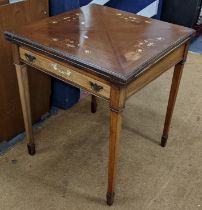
left=5, top=4, right=194, bottom=205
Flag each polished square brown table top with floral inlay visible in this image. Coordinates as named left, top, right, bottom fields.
left=5, top=4, right=194, bottom=84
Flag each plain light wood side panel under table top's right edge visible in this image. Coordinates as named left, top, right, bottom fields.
left=126, top=44, right=186, bottom=98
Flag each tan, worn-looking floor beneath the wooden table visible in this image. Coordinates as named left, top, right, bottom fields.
left=0, top=54, right=202, bottom=210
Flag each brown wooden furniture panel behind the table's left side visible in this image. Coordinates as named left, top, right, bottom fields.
left=0, top=0, right=51, bottom=142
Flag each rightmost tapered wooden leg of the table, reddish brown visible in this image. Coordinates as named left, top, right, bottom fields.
left=161, top=63, right=184, bottom=147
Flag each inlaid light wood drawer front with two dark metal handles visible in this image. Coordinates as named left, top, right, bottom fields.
left=20, top=48, right=110, bottom=99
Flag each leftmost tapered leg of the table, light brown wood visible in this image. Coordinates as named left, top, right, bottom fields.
left=15, top=64, right=35, bottom=155
